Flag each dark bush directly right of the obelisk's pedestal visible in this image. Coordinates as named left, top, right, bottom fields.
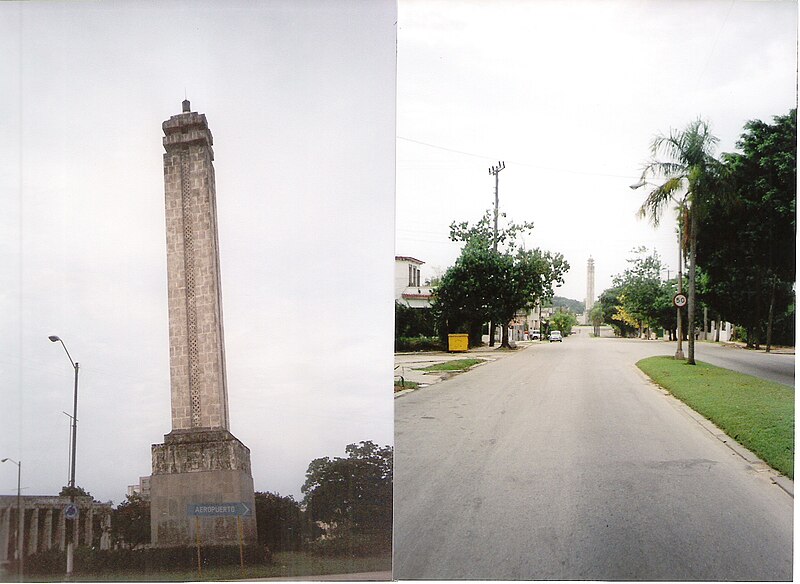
left=255, top=493, right=302, bottom=552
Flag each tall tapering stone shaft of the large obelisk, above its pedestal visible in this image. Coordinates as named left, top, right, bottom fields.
left=162, top=101, right=229, bottom=430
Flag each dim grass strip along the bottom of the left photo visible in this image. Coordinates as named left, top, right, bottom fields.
left=29, top=552, right=392, bottom=582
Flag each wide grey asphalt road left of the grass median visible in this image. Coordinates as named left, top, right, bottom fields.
left=394, top=336, right=793, bottom=580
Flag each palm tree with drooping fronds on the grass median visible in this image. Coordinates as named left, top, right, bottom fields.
left=639, top=118, right=723, bottom=365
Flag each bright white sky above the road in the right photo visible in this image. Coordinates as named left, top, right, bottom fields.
left=396, top=0, right=797, bottom=301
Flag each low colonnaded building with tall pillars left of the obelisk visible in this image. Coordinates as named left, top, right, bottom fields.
left=0, top=495, right=111, bottom=564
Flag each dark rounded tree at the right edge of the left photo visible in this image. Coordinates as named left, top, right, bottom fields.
left=302, top=441, right=393, bottom=545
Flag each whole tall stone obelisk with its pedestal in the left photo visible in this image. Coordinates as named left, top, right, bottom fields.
left=150, top=100, right=256, bottom=546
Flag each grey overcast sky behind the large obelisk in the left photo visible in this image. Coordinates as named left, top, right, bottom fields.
left=0, top=0, right=397, bottom=503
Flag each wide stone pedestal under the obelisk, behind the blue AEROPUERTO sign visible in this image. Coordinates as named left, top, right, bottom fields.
left=150, top=428, right=258, bottom=547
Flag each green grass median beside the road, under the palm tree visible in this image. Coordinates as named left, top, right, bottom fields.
left=636, top=357, right=794, bottom=478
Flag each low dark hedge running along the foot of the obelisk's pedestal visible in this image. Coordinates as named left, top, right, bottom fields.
left=18, top=545, right=267, bottom=575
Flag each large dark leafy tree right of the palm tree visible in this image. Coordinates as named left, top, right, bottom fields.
left=698, top=109, right=797, bottom=350
